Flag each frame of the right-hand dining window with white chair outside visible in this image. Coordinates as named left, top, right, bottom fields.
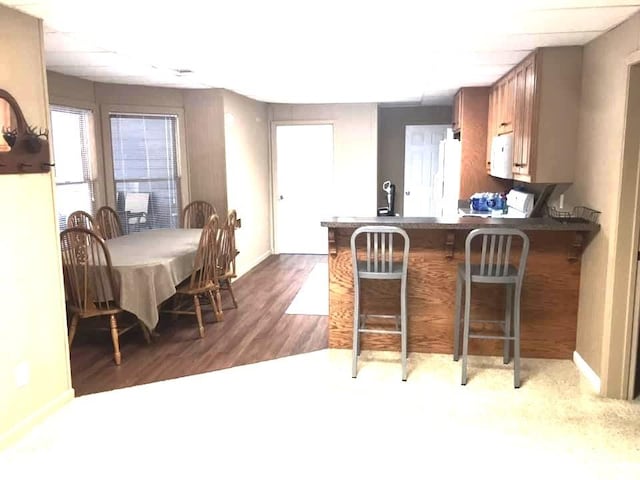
left=101, top=105, right=190, bottom=221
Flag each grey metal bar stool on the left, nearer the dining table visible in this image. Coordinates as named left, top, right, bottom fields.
left=351, top=226, right=409, bottom=381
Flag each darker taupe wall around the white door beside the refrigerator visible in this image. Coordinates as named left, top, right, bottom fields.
left=376, top=106, right=452, bottom=214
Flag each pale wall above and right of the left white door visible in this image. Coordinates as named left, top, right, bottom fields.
left=269, top=103, right=382, bottom=217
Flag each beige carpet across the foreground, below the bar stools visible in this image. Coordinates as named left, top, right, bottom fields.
left=0, top=350, right=640, bottom=480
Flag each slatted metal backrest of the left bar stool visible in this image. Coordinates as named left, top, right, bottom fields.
left=351, top=225, right=409, bottom=278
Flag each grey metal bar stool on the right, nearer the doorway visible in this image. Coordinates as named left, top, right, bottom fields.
left=453, top=228, right=529, bottom=388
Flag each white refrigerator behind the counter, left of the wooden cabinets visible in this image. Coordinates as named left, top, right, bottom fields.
left=432, top=136, right=461, bottom=217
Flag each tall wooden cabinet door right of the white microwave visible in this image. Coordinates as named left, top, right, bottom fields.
left=513, top=56, right=536, bottom=177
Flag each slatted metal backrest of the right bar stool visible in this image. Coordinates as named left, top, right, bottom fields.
left=465, top=228, right=529, bottom=284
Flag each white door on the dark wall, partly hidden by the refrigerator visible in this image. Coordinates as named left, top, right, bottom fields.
left=403, top=125, right=448, bottom=217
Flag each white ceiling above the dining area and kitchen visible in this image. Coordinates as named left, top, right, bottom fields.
left=0, top=0, right=640, bottom=105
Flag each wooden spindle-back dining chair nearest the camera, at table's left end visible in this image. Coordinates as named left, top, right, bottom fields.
left=60, top=227, right=151, bottom=365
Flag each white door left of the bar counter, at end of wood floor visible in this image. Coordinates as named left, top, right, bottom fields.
left=274, top=124, right=333, bottom=254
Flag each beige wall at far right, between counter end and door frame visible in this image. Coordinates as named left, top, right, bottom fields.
left=566, top=15, right=640, bottom=386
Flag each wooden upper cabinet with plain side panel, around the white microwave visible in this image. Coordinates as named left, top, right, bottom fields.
left=487, top=47, right=582, bottom=183
